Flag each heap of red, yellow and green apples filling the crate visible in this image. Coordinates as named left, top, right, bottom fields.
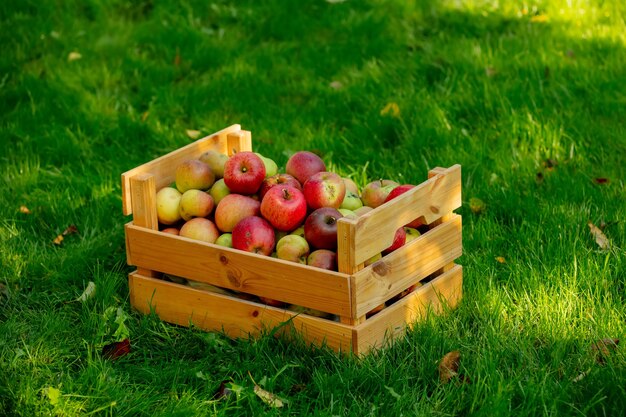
left=156, top=151, right=421, bottom=312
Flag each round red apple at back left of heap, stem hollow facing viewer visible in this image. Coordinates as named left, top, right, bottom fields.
left=224, top=151, right=265, bottom=194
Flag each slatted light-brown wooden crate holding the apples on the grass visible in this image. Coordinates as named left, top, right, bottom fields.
left=122, top=125, right=463, bottom=354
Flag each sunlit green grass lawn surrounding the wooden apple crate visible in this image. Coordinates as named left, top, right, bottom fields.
left=0, top=0, right=626, bottom=416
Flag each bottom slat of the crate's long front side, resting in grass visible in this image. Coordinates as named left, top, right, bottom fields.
left=129, top=273, right=352, bottom=351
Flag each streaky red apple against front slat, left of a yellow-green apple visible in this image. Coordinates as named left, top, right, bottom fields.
left=233, top=216, right=275, bottom=256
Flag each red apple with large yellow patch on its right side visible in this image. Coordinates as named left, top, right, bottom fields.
left=302, top=171, right=346, bottom=210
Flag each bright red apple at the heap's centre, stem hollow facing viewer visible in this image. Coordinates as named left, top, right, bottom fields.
left=261, top=185, right=307, bottom=232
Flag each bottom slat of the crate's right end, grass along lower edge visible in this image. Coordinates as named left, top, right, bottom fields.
left=353, top=265, right=463, bottom=355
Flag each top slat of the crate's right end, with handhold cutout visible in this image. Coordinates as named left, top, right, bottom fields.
left=338, top=165, right=461, bottom=265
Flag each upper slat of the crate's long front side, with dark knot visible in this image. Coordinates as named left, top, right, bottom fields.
left=126, top=223, right=352, bottom=316
